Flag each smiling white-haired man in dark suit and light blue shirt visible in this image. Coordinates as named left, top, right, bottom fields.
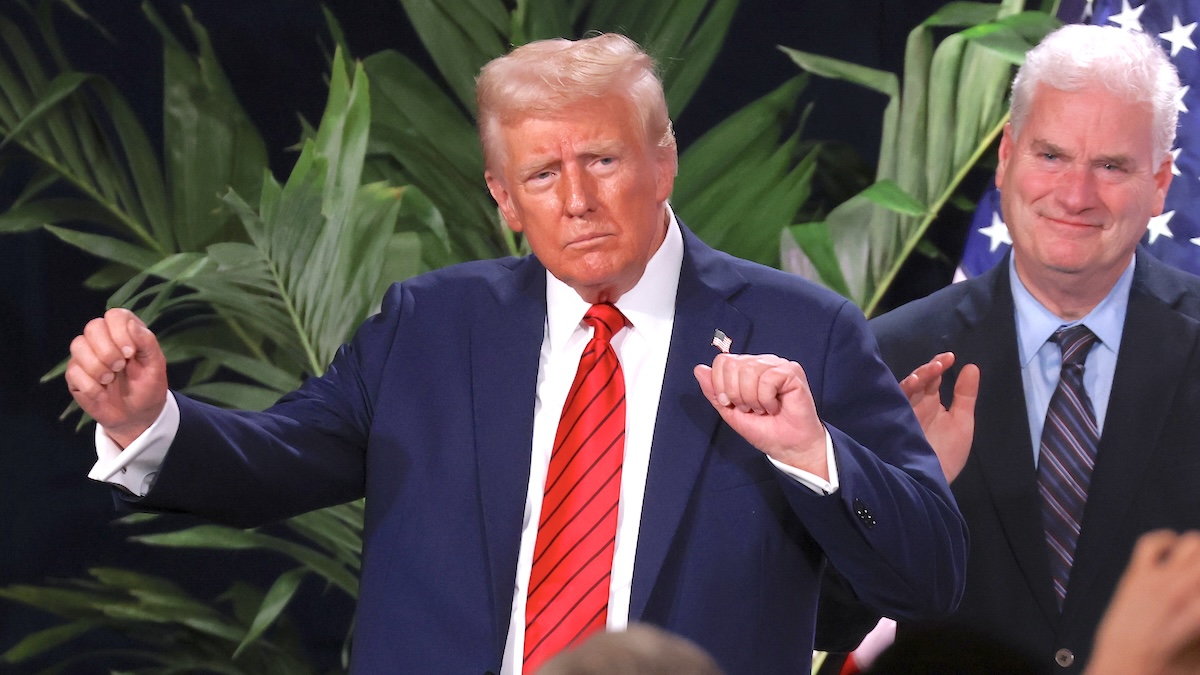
left=830, top=25, right=1200, bottom=673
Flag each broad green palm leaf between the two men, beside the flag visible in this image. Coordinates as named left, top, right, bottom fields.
left=782, top=0, right=1058, bottom=316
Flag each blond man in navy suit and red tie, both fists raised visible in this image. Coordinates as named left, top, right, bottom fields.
left=66, top=35, right=966, bottom=674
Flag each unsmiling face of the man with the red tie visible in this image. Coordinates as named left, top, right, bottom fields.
left=486, top=95, right=676, bottom=303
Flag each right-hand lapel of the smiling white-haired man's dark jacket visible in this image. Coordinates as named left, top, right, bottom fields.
left=1063, top=253, right=1200, bottom=614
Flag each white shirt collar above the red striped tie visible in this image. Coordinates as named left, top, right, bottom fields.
left=546, top=204, right=683, bottom=351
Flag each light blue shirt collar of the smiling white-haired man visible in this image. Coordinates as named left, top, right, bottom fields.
left=1008, top=256, right=1138, bottom=368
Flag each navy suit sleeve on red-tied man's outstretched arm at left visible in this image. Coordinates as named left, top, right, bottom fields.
left=119, top=285, right=404, bottom=527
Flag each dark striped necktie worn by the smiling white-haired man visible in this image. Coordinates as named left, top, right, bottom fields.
left=1038, top=324, right=1100, bottom=609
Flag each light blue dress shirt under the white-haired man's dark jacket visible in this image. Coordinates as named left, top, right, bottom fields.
left=1008, top=256, right=1134, bottom=466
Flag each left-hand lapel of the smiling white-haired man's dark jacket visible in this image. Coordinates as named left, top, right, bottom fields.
left=955, top=258, right=1058, bottom=623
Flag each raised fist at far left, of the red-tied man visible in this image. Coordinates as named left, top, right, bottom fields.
left=66, top=309, right=167, bottom=448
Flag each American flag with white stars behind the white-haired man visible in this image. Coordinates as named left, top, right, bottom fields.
left=959, top=0, right=1200, bottom=277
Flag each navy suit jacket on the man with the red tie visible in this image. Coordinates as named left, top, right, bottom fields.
left=139, top=231, right=966, bottom=673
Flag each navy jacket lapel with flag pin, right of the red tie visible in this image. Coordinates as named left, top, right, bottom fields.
left=629, top=228, right=750, bottom=621
